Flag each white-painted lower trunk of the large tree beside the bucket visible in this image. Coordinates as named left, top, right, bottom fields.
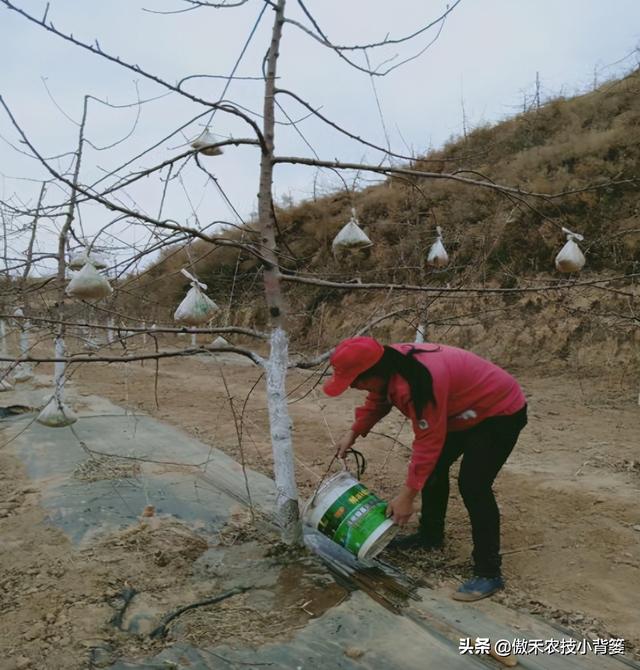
left=265, top=328, right=302, bottom=544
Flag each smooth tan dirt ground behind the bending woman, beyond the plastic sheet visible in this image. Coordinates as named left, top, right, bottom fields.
left=75, top=355, right=640, bottom=645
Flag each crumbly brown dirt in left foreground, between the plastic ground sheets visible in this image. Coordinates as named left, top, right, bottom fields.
left=0, top=434, right=348, bottom=670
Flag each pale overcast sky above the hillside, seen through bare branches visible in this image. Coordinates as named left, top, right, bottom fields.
left=0, top=0, right=640, bottom=272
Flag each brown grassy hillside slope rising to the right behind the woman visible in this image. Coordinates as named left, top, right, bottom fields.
left=131, top=71, right=640, bottom=374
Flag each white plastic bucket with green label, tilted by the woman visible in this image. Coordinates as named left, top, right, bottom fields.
left=303, top=472, right=398, bottom=559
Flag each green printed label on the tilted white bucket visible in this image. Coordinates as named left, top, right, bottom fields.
left=318, top=484, right=387, bottom=555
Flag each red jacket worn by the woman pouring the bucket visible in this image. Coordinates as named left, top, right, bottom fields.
left=352, top=342, right=526, bottom=491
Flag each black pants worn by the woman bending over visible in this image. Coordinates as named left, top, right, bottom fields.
left=420, top=405, right=527, bottom=577
